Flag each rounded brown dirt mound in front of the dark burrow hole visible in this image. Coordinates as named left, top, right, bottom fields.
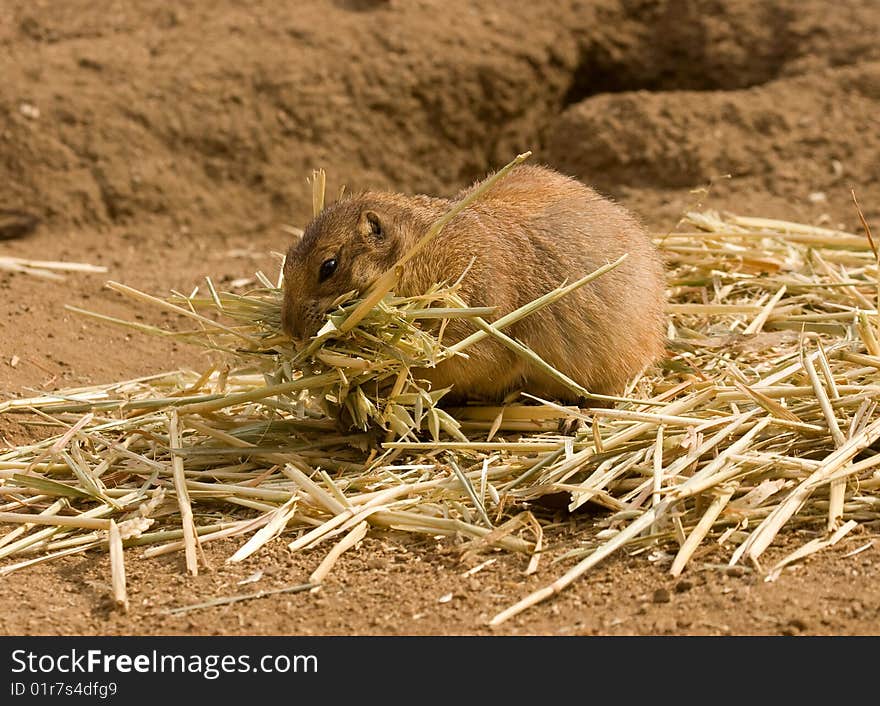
left=546, top=63, right=880, bottom=198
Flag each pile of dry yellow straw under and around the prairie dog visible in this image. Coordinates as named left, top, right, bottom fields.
left=0, top=158, right=880, bottom=624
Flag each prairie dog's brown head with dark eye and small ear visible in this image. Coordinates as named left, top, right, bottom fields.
left=281, top=193, right=403, bottom=340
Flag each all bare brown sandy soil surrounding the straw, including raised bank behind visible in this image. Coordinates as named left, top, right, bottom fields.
left=0, top=0, right=880, bottom=634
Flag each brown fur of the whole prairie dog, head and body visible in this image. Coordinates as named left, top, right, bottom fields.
left=282, top=166, right=664, bottom=401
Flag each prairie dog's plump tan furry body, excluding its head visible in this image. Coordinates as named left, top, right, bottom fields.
left=396, top=166, right=665, bottom=400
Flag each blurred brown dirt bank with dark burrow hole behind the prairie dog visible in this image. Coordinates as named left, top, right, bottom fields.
left=6, top=0, right=880, bottom=233
